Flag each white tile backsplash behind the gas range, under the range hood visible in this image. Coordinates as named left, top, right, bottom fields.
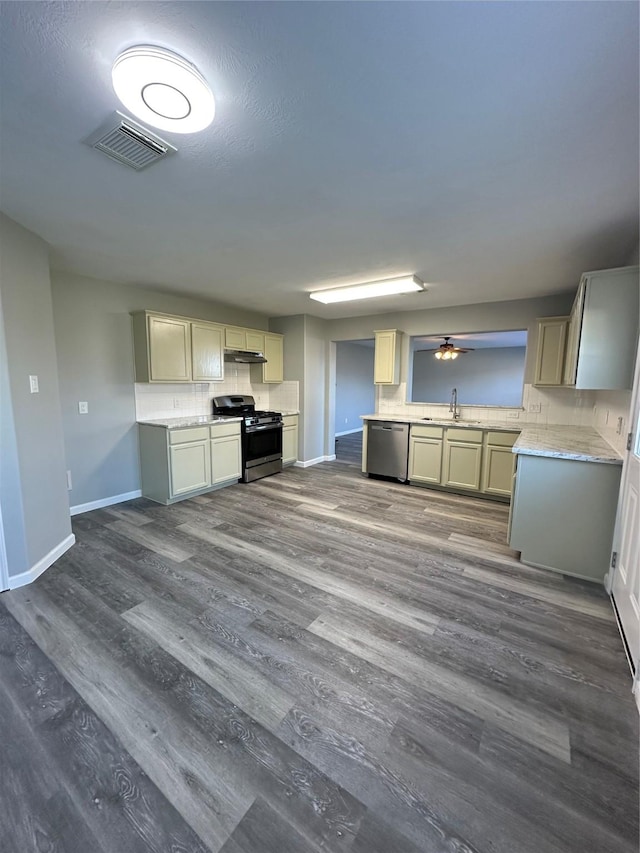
left=135, top=364, right=299, bottom=421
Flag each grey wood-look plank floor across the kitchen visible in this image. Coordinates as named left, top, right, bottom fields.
left=0, top=436, right=638, bottom=853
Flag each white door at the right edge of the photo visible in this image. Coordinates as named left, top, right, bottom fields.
left=611, top=344, right=640, bottom=707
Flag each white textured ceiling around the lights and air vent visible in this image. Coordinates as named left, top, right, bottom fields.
left=0, top=2, right=639, bottom=318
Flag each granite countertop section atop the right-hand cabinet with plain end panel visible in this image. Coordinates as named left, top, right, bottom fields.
left=513, top=424, right=622, bottom=465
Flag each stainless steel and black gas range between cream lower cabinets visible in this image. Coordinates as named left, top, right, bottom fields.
left=213, top=394, right=282, bottom=483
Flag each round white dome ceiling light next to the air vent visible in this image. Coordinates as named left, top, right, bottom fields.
left=111, top=46, right=215, bottom=133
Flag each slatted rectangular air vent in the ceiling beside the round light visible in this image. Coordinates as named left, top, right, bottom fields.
left=84, top=112, right=178, bottom=172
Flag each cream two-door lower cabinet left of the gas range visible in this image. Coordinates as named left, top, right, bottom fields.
left=138, top=421, right=242, bottom=504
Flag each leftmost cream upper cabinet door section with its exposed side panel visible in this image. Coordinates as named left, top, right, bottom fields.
left=133, top=311, right=191, bottom=382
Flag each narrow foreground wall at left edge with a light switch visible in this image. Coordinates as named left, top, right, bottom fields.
left=0, top=214, right=71, bottom=578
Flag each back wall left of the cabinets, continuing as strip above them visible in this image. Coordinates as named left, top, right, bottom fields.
left=51, top=272, right=268, bottom=507
